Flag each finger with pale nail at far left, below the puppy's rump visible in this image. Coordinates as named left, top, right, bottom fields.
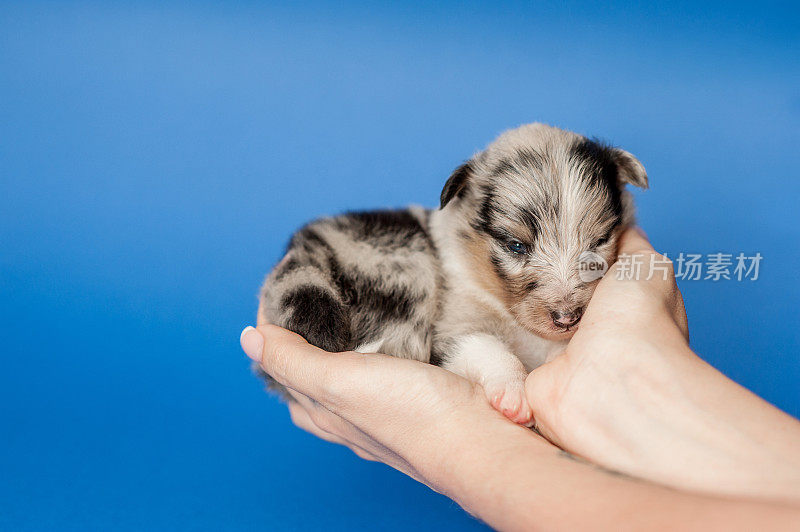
left=240, top=324, right=346, bottom=402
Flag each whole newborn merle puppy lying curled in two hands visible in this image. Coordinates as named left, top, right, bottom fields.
left=261, top=124, right=647, bottom=424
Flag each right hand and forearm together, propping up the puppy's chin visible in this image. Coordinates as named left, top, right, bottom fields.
left=526, top=229, right=800, bottom=497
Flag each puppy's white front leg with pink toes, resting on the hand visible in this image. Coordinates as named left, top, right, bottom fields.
left=441, top=333, right=533, bottom=425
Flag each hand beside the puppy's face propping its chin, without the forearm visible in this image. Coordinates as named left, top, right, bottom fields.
left=526, top=229, right=694, bottom=471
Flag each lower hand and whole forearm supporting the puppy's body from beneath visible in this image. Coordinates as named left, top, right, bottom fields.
left=241, top=312, right=797, bottom=530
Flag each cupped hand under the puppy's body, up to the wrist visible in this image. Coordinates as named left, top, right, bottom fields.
left=241, top=323, right=524, bottom=491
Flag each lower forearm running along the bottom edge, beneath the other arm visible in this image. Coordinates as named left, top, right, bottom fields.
left=422, top=420, right=800, bottom=530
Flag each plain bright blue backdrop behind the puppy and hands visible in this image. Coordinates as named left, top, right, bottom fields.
left=0, top=2, right=800, bottom=530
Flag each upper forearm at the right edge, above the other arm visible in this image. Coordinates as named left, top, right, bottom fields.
left=638, top=353, right=800, bottom=502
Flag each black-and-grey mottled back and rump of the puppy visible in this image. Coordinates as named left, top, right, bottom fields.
left=261, top=207, right=439, bottom=386
